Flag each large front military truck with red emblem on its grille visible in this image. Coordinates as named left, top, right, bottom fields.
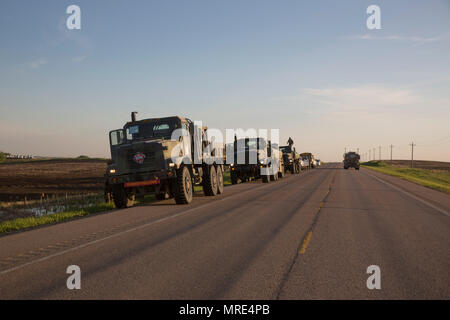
left=105, top=112, right=224, bottom=208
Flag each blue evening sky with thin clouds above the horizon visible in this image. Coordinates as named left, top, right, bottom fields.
left=0, top=0, right=450, bottom=161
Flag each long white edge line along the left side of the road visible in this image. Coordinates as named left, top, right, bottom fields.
left=0, top=176, right=286, bottom=275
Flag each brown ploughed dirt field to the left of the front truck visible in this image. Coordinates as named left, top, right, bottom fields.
left=0, top=159, right=106, bottom=201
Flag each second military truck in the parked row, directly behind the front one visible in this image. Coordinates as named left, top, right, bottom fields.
left=230, top=137, right=284, bottom=184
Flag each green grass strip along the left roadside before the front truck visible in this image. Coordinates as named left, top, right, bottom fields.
left=0, top=203, right=114, bottom=233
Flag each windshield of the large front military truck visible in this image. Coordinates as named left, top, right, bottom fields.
left=126, top=120, right=179, bottom=140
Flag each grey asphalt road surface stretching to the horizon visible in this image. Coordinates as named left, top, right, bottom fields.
left=0, top=164, right=450, bottom=299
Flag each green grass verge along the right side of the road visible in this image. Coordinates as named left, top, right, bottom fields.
left=361, top=161, right=450, bottom=193
